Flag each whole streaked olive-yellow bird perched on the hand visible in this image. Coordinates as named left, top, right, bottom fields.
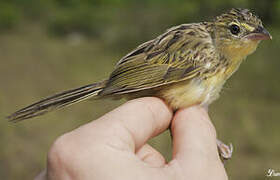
left=8, top=9, right=271, bottom=160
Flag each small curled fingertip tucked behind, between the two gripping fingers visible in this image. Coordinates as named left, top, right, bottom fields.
left=136, top=144, right=165, bottom=167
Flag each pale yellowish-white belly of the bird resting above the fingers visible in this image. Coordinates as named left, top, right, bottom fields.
left=160, top=76, right=225, bottom=109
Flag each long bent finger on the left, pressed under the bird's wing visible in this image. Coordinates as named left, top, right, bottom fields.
left=83, top=97, right=173, bottom=152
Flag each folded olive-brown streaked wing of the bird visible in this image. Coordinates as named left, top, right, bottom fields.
left=101, top=23, right=215, bottom=95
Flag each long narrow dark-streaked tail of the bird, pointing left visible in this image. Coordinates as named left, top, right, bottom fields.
left=7, top=81, right=105, bottom=122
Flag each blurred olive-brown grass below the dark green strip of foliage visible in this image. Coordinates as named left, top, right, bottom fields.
left=0, top=24, right=280, bottom=180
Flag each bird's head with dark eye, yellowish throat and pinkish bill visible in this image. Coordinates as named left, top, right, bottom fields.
left=213, top=8, right=272, bottom=59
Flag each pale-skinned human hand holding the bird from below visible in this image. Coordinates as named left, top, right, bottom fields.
left=35, top=97, right=228, bottom=180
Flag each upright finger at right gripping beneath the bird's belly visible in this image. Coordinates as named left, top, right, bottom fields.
left=172, top=106, right=220, bottom=169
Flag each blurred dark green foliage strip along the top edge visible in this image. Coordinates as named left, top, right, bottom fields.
left=0, top=0, right=280, bottom=36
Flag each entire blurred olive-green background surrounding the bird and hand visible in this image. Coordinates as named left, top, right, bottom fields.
left=0, top=0, right=280, bottom=180
